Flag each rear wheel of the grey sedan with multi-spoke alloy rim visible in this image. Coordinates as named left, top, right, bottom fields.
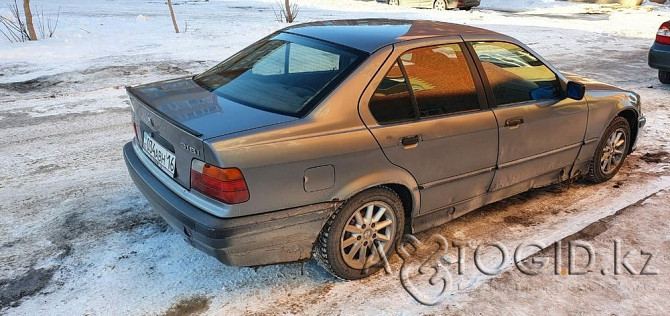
left=314, top=187, right=405, bottom=280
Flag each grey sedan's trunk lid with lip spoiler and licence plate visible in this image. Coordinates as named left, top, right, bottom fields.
left=127, top=78, right=296, bottom=189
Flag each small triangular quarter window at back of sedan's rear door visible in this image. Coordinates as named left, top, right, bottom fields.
left=370, top=62, right=416, bottom=124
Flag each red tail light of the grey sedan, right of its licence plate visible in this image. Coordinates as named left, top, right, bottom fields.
left=191, top=159, right=249, bottom=204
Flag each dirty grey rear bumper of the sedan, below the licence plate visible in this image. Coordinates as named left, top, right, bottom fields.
left=123, top=142, right=340, bottom=266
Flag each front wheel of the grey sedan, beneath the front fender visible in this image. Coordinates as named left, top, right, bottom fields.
left=587, top=116, right=632, bottom=183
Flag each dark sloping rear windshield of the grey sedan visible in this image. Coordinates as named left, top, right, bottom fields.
left=194, top=33, right=365, bottom=117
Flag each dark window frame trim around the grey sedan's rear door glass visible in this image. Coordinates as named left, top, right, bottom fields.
left=368, top=40, right=490, bottom=126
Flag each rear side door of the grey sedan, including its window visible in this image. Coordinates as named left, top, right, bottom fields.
left=361, top=40, right=498, bottom=213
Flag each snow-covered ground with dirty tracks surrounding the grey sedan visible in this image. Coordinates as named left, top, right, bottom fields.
left=0, top=0, right=670, bottom=315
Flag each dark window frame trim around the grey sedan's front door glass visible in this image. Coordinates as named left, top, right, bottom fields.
left=465, top=39, right=565, bottom=109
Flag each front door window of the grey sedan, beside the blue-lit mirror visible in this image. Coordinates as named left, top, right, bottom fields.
left=472, top=42, right=561, bottom=105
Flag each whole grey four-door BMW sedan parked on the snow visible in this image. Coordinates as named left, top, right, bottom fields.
left=123, top=19, right=646, bottom=279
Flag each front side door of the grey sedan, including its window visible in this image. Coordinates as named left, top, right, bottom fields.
left=471, top=41, right=588, bottom=191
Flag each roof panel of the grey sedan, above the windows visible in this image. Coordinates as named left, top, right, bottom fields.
left=282, top=19, right=501, bottom=53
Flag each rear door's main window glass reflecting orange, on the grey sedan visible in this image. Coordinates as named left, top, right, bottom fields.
left=400, top=44, right=480, bottom=118
